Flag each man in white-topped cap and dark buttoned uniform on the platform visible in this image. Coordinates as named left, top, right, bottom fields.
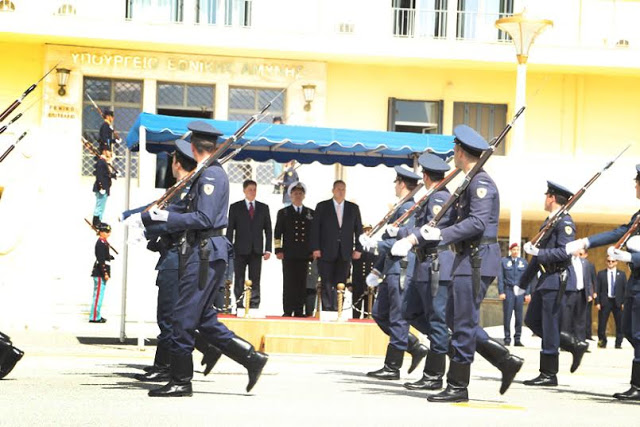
left=274, top=181, right=313, bottom=317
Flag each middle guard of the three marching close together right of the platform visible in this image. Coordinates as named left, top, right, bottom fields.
left=398, top=153, right=455, bottom=390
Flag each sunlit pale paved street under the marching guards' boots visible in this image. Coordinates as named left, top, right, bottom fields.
left=0, top=326, right=640, bottom=426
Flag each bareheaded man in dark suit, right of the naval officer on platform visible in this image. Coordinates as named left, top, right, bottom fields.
left=311, top=180, right=362, bottom=311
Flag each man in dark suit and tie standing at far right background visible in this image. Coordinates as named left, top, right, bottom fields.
left=596, top=256, right=627, bottom=348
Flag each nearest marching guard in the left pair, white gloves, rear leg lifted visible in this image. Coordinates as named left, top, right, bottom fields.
left=131, top=121, right=267, bottom=397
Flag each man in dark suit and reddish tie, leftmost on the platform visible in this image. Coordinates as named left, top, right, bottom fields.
left=227, top=179, right=273, bottom=308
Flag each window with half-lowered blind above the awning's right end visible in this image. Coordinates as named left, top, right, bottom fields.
left=387, top=98, right=442, bottom=133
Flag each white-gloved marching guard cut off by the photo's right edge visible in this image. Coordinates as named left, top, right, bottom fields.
left=566, top=164, right=640, bottom=401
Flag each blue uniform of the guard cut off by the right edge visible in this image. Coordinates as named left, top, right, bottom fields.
left=587, top=164, right=640, bottom=401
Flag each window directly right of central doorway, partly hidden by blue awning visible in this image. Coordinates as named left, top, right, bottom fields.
left=227, top=87, right=286, bottom=184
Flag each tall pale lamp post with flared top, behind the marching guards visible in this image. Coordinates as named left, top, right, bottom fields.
left=495, top=12, right=553, bottom=244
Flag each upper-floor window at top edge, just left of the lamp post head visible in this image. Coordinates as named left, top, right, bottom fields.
left=456, top=0, right=513, bottom=41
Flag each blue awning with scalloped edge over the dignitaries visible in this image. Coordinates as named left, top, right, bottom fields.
left=127, top=113, right=453, bottom=166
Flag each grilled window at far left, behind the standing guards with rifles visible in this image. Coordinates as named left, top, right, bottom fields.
left=82, top=77, right=142, bottom=178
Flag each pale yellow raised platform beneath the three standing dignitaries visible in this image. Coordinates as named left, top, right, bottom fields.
left=218, top=315, right=389, bottom=356
